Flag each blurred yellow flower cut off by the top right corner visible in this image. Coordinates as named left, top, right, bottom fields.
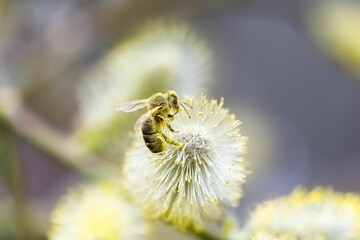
left=309, top=0, right=360, bottom=78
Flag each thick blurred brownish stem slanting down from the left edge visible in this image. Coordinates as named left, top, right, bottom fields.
left=0, top=89, right=118, bottom=178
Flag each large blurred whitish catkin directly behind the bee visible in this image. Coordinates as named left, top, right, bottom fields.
left=77, top=21, right=212, bottom=156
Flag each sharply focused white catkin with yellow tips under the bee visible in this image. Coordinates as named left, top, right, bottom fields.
left=124, top=95, right=247, bottom=230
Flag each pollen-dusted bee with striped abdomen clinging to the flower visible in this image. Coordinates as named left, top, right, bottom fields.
left=115, top=91, right=190, bottom=153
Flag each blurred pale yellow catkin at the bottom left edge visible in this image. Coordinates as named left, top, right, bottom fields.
left=49, top=182, right=149, bottom=240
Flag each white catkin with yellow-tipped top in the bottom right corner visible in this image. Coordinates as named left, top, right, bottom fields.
left=240, top=188, right=360, bottom=240
